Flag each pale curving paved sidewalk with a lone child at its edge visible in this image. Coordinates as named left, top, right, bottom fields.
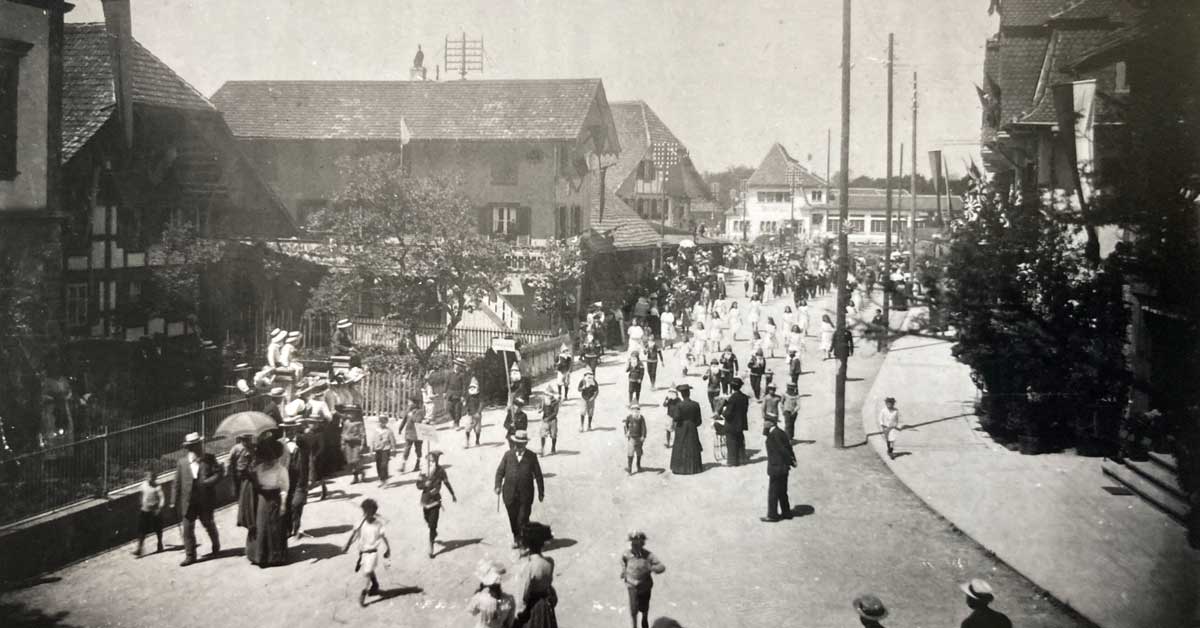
left=863, top=336, right=1200, bottom=628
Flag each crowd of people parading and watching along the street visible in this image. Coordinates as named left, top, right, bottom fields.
left=137, top=247, right=1002, bottom=628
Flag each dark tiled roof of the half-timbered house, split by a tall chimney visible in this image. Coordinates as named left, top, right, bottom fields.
left=62, top=24, right=215, bottom=160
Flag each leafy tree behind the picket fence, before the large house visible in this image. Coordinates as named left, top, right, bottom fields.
left=308, top=154, right=508, bottom=371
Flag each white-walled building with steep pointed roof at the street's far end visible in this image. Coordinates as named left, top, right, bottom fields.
left=725, top=143, right=829, bottom=241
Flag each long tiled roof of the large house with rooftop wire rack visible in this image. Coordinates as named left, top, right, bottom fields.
left=212, top=78, right=604, bottom=140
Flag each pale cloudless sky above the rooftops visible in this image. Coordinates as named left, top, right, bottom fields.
left=67, top=0, right=997, bottom=177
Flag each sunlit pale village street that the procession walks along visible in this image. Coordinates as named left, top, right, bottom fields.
left=0, top=282, right=1087, bottom=628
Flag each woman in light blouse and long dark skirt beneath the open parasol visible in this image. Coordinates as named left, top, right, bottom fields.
left=246, top=437, right=289, bottom=568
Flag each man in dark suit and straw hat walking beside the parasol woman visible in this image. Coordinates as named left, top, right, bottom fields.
left=172, top=432, right=223, bottom=567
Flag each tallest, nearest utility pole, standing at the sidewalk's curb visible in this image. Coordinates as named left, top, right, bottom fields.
left=833, top=0, right=850, bottom=449
